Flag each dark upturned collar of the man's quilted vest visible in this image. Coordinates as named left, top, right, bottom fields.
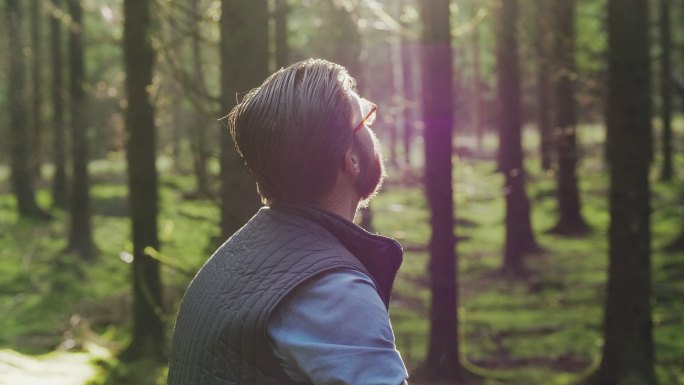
left=271, top=203, right=403, bottom=308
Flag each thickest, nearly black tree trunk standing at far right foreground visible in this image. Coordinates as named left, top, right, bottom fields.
left=596, top=0, right=656, bottom=385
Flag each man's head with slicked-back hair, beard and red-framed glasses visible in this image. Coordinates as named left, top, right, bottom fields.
left=228, top=59, right=384, bottom=204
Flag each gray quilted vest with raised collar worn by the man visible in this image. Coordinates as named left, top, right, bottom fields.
left=168, top=204, right=402, bottom=385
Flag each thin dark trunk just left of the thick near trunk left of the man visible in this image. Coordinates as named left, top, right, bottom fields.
left=68, top=0, right=95, bottom=259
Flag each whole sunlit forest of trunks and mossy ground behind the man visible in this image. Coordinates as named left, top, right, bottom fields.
left=0, top=0, right=684, bottom=385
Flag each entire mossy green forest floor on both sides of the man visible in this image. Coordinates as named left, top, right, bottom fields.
left=0, top=127, right=684, bottom=385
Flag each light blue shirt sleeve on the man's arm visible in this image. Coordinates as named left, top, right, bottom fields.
left=267, top=269, right=408, bottom=385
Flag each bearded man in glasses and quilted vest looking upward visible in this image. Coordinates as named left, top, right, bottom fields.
left=168, top=59, right=407, bottom=385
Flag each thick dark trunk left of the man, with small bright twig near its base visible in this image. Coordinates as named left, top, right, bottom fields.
left=123, top=0, right=164, bottom=360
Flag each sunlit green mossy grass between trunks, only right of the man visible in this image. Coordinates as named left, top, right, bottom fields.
left=373, top=127, right=684, bottom=384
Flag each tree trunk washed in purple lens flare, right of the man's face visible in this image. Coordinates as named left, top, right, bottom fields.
left=420, top=0, right=465, bottom=379
